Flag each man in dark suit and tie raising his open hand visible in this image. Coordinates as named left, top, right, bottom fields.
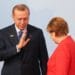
left=0, top=4, right=48, bottom=75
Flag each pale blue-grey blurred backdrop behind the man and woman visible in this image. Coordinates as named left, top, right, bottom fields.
left=0, top=0, right=75, bottom=73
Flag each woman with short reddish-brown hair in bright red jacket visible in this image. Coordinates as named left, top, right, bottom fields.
left=47, top=17, right=75, bottom=75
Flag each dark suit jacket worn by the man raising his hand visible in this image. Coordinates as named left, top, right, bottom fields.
left=0, top=24, right=48, bottom=75
